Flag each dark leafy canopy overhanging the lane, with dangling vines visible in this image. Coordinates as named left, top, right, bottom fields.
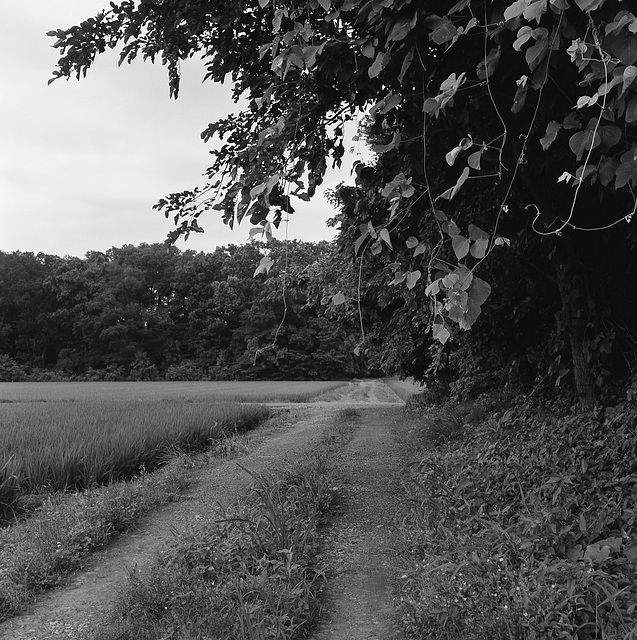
left=50, top=0, right=637, bottom=401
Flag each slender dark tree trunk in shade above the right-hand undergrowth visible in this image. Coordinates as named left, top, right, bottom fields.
left=557, top=264, right=597, bottom=409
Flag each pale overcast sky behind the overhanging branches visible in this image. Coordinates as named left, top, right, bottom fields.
left=0, top=0, right=353, bottom=257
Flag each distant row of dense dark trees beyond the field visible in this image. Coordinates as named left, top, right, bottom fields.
left=0, top=240, right=363, bottom=381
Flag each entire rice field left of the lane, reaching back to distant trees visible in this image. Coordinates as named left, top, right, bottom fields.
left=0, top=382, right=344, bottom=516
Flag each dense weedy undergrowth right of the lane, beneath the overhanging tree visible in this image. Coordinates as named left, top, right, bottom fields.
left=400, top=396, right=637, bottom=640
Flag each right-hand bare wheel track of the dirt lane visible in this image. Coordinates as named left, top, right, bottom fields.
left=311, top=408, right=404, bottom=640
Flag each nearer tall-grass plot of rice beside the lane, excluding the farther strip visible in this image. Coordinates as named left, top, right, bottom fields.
left=0, top=401, right=268, bottom=508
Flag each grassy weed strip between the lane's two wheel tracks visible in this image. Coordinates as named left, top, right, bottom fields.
left=93, top=410, right=356, bottom=640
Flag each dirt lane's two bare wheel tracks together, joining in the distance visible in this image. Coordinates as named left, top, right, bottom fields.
left=0, top=381, right=410, bottom=640
